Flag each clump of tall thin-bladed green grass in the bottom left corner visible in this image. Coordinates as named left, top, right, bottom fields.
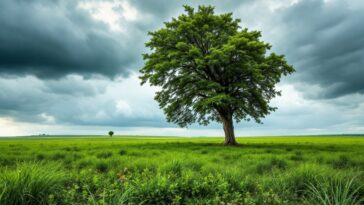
left=0, top=163, right=64, bottom=205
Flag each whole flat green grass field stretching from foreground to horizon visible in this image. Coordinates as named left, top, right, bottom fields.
left=0, top=136, right=364, bottom=205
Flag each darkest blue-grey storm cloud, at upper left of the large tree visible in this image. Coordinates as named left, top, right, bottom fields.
left=0, top=0, right=140, bottom=78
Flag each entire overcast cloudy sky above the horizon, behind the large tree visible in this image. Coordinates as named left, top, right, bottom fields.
left=0, top=0, right=364, bottom=136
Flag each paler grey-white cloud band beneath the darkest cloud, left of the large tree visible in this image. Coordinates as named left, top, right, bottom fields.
left=0, top=75, right=171, bottom=127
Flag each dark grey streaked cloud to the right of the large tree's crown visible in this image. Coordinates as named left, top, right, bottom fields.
left=277, top=0, right=364, bottom=98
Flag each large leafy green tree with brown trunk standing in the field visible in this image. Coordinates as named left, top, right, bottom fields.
left=140, top=6, right=294, bottom=145
